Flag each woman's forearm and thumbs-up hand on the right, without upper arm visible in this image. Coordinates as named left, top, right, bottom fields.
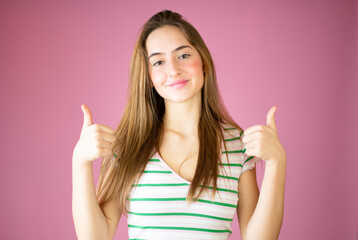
left=242, top=107, right=286, bottom=240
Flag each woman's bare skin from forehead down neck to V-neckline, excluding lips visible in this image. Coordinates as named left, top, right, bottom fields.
left=146, top=26, right=204, bottom=178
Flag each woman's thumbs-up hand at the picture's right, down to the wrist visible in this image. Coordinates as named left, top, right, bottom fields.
left=242, top=106, right=286, bottom=163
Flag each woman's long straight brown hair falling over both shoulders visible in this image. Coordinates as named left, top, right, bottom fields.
left=97, top=10, right=242, bottom=219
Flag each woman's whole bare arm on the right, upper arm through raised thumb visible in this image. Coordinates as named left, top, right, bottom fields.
left=238, top=106, right=287, bottom=239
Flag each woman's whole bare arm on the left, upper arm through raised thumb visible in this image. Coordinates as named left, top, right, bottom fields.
left=72, top=105, right=120, bottom=239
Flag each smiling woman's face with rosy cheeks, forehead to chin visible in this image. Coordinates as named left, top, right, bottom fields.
left=146, top=26, right=204, bottom=102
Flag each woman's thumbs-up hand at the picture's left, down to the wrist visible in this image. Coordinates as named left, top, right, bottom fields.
left=73, top=104, right=115, bottom=166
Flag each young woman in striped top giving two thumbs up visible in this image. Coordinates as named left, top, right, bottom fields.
left=72, top=10, right=286, bottom=239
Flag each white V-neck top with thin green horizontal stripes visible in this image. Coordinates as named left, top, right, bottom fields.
left=127, top=128, right=261, bottom=240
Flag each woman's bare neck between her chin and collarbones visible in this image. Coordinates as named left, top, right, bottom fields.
left=163, top=91, right=201, bottom=136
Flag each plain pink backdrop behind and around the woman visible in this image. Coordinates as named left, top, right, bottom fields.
left=0, top=0, right=358, bottom=240
